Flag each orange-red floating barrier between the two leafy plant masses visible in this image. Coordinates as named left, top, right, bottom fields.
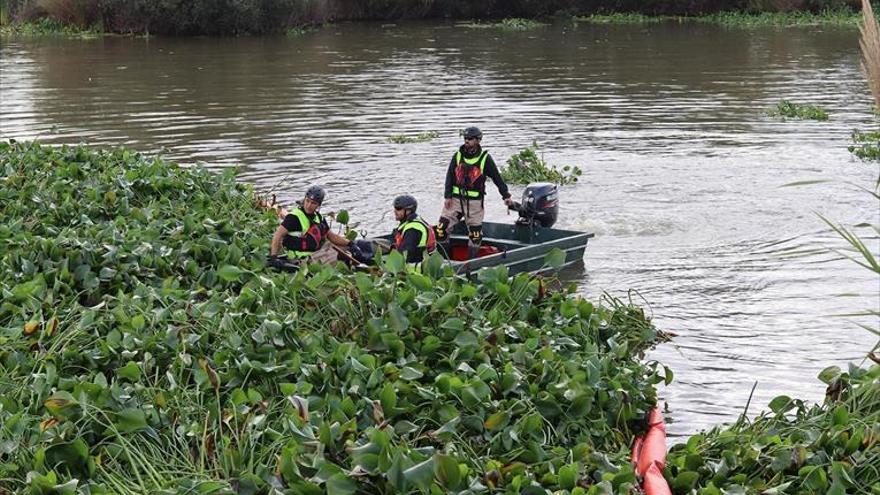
left=632, top=407, right=672, bottom=495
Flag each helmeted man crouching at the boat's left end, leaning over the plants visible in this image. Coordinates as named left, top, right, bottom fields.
left=268, top=186, right=351, bottom=269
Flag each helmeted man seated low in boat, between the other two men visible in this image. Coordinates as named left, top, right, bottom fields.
left=349, top=194, right=437, bottom=265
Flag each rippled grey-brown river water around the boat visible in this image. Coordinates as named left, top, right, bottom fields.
left=0, top=23, right=880, bottom=435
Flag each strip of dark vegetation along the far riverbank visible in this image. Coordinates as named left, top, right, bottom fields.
left=3, top=0, right=858, bottom=35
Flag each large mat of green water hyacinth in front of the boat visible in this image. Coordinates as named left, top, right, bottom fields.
left=0, top=142, right=671, bottom=494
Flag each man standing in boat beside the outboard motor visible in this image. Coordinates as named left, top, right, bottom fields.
left=437, top=127, right=513, bottom=257
